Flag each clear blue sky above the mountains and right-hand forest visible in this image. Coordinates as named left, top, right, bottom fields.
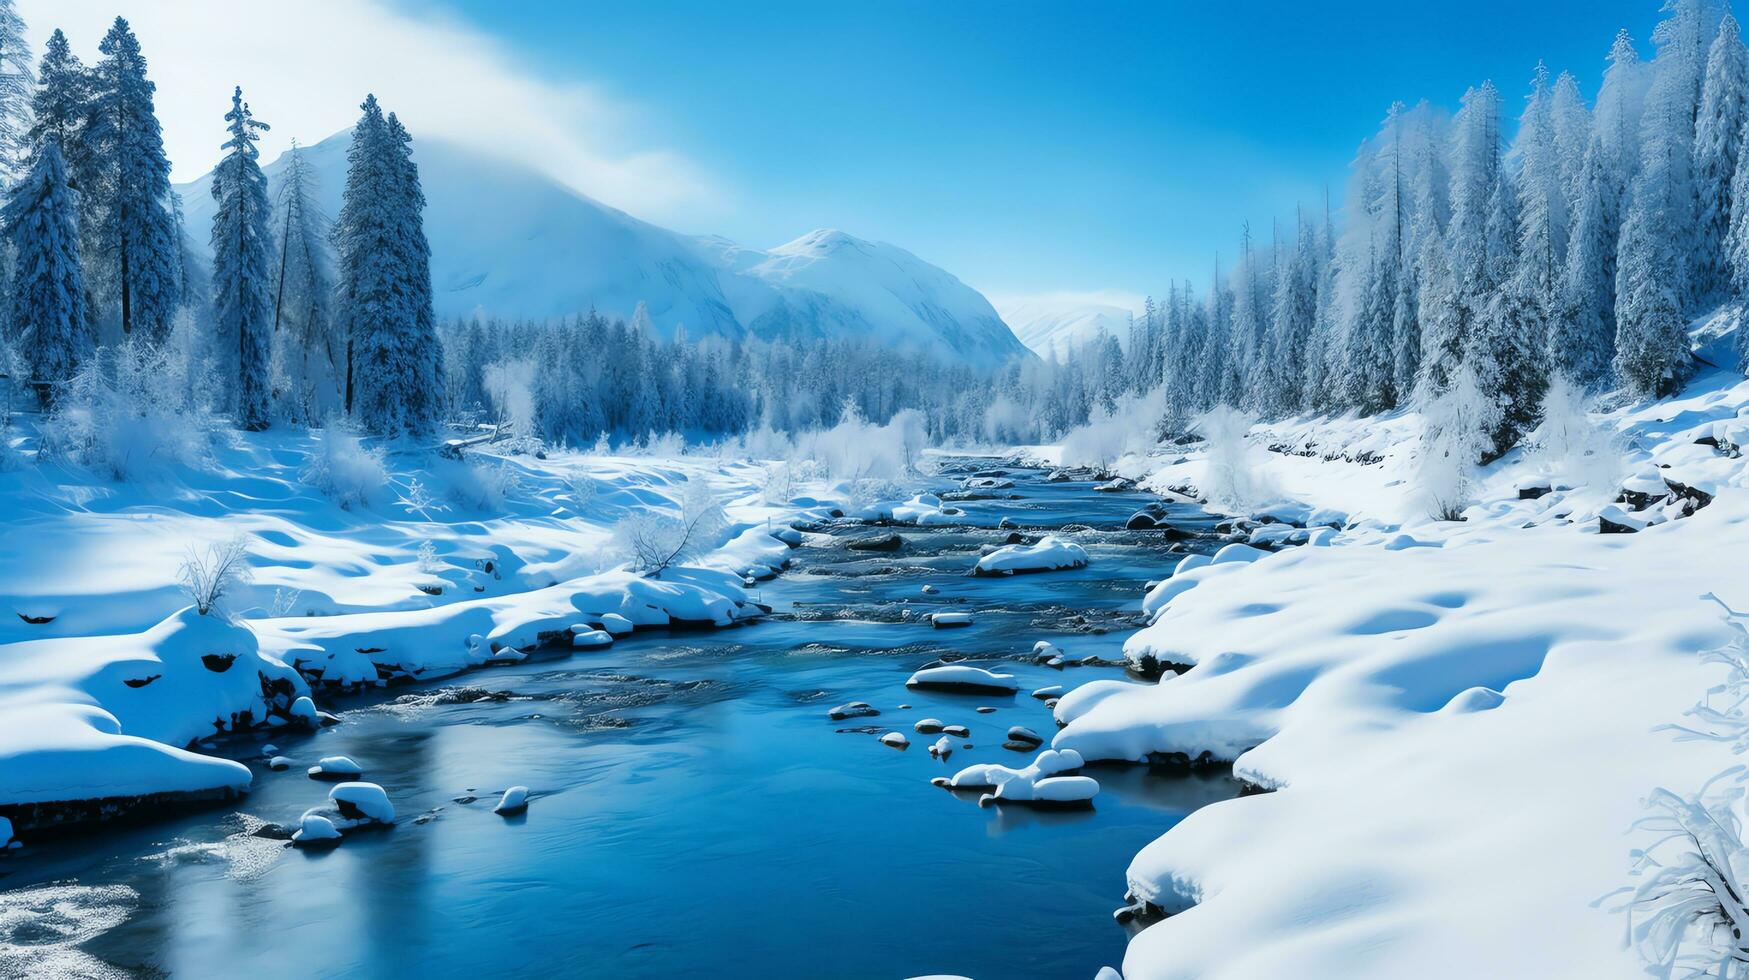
left=444, top=0, right=1658, bottom=304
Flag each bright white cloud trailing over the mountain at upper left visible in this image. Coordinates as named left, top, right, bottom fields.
left=19, top=0, right=726, bottom=224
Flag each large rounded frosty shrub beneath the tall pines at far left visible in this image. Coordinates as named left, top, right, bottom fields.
left=42, top=338, right=217, bottom=480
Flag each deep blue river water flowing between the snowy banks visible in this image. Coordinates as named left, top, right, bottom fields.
left=0, top=469, right=1238, bottom=980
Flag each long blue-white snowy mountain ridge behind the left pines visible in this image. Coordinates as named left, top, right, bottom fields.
left=178, top=133, right=1027, bottom=366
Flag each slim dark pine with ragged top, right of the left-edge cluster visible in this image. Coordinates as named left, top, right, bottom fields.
left=212, top=86, right=273, bottom=431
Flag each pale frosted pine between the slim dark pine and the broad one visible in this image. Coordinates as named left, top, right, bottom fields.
left=273, top=140, right=334, bottom=422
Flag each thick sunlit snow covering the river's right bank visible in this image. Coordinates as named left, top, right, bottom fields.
left=1037, top=365, right=1749, bottom=980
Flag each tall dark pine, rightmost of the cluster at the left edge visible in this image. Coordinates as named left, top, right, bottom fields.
left=82, top=18, right=180, bottom=341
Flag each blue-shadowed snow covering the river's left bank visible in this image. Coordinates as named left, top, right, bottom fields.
left=0, top=427, right=874, bottom=819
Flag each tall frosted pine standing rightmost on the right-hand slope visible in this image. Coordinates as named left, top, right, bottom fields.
left=1691, top=14, right=1749, bottom=303
